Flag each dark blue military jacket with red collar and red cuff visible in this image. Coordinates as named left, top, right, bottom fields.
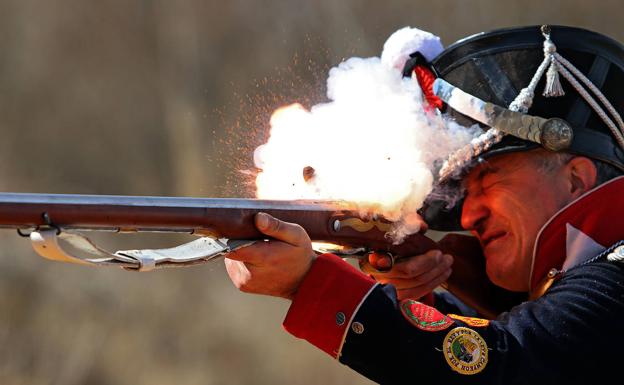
left=284, top=178, right=624, bottom=384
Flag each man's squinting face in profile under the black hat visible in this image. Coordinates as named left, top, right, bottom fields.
left=461, top=150, right=570, bottom=291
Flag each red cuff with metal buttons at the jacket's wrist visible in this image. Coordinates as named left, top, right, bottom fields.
left=283, top=254, right=375, bottom=358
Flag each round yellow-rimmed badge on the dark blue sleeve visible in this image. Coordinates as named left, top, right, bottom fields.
left=442, top=327, right=488, bottom=374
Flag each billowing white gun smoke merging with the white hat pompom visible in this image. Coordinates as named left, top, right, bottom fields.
left=254, top=27, right=480, bottom=243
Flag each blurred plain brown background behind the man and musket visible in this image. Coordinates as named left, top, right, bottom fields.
left=0, top=0, right=624, bottom=385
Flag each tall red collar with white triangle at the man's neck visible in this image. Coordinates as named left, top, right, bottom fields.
left=530, top=176, right=624, bottom=291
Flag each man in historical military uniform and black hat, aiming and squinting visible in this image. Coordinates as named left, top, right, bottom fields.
left=226, top=26, right=624, bottom=384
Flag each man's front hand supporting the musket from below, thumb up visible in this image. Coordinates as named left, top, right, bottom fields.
left=225, top=213, right=316, bottom=299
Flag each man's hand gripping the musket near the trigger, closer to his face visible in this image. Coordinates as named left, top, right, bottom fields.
left=369, top=250, right=453, bottom=300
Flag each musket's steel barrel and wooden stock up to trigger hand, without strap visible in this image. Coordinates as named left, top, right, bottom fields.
left=0, top=193, right=442, bottom=254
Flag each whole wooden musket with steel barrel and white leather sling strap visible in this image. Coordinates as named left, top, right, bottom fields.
left=0, top=193, right=524, bottom=316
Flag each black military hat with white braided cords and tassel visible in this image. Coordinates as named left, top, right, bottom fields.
left=414, top=26, right=624, bottom=231
